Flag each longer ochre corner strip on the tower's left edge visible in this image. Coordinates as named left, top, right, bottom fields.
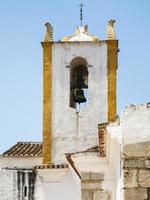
left=42, top=42, right=53, bottom=164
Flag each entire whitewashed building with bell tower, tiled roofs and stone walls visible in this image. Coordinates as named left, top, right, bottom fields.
left=0, top=20, right=150, bottom=200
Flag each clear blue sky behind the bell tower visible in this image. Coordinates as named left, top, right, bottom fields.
left=0, top=0, right=150, bottom=152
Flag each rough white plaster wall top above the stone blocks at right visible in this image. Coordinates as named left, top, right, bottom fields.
left=120, top=104, right=150, bottom=145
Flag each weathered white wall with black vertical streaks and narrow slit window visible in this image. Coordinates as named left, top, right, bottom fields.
left=0, top=169, right=42, bottom=200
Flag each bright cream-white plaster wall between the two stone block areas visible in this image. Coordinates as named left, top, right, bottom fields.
left=69, top=123, right=122, bottom=200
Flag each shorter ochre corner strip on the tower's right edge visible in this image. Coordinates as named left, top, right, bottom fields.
left=107, top=40, right=118, bottom=121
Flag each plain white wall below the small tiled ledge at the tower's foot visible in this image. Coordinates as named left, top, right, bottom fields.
left=35, top=169, right=81, bottom=200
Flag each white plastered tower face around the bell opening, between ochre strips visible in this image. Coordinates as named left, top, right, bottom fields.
left=52, top=42, right=107, bottom=163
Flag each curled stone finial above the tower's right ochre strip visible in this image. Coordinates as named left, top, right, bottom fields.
left=107, top=19, right=116, bottom=40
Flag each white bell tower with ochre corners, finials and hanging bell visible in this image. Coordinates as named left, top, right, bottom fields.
left=42, top=20, right=118, bottom=164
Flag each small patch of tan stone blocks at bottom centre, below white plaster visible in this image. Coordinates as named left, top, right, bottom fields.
left=81, top=172, right=111, bottom=200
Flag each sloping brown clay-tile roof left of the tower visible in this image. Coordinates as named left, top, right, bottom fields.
left=1, top=142, right=42, bottom=157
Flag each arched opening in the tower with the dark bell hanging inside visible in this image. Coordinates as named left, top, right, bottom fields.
left=70, top=57, right=88, bottom=111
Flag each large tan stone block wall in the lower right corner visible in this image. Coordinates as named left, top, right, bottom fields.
left=123, top=142, right=150, bottom=200
